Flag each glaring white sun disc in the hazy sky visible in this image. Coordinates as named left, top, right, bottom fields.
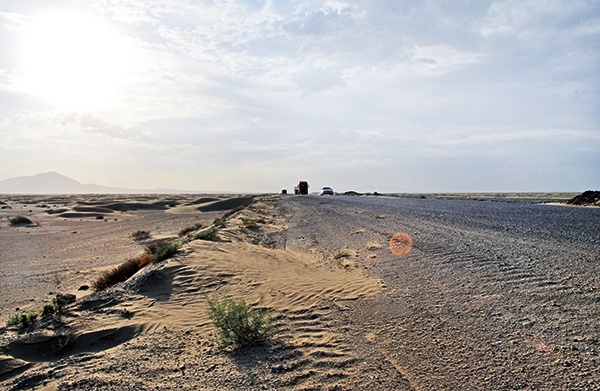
left=23, top=12, right=131, bottom=111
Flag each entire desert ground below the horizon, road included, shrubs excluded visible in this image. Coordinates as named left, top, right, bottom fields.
left=0, top=195, right=600, bottom=390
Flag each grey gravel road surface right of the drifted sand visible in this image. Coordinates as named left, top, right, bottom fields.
left=271, top=195, right=600, bottom=390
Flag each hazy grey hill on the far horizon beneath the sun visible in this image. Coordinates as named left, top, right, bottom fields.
left=0, top=172, right=183, bottom=194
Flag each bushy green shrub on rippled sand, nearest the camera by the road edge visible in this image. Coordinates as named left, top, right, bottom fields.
left=206, top=296, right=276, bottom=347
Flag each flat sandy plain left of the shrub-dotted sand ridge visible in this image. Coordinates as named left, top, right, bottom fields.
left=0, top=195, right=244, bottom=318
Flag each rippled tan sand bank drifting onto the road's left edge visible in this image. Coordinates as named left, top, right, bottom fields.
left=0, top=198, right=404, bottom=389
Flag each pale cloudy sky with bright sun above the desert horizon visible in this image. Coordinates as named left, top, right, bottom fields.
left=0, top=0, right=600, bottom=193
